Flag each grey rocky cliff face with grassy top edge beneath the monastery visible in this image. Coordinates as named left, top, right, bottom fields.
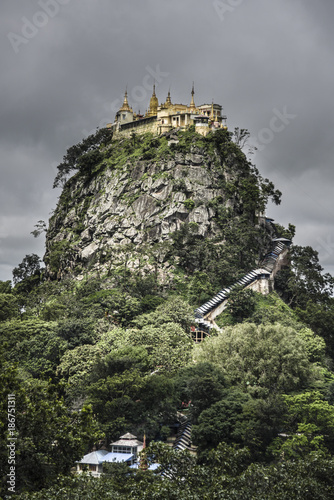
left=44, top=132, right=274, bottom=284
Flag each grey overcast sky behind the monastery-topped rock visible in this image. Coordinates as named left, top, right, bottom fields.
left=0, top=0, right=334, bottom=280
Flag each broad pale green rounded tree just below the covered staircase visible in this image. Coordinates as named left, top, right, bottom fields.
left=194, top=323, right=321, bottom=397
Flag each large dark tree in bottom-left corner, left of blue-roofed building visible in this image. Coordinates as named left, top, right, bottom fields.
left=1, top=379, right=100, bottom=491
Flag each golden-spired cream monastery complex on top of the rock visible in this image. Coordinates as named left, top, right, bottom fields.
left=107, top=84, right=227, bottom=137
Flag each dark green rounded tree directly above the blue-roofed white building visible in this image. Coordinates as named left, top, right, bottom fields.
left=81, top=346, right=178, bottom=438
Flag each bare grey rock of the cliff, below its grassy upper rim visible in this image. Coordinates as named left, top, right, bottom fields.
left=44, top=133, right=260, bottom=277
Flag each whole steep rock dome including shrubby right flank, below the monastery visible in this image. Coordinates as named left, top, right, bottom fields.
left=45, top=130, right=280, bottom=290
